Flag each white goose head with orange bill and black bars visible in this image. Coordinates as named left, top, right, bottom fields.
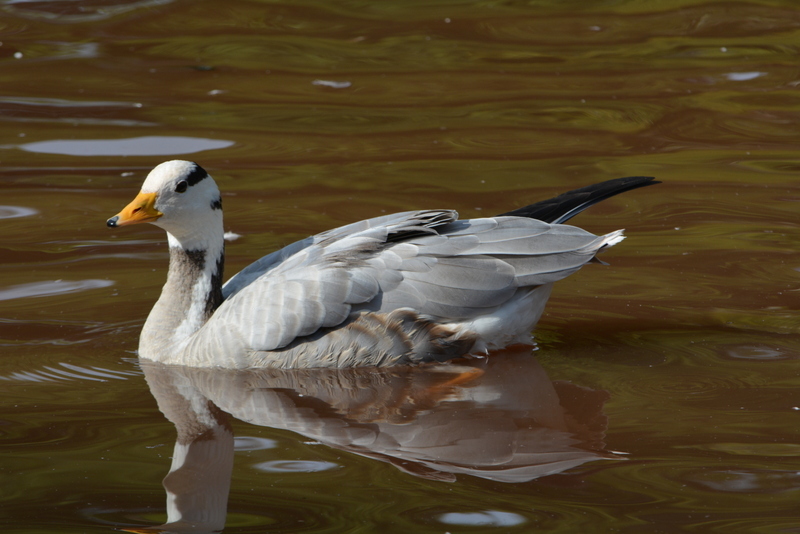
left=106, top=160, right=222, bottom=250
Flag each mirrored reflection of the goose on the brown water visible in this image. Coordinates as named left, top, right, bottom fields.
left=129, top=348, right=614, bottom=532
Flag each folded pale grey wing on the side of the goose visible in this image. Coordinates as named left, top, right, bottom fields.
left=199, top=211, right=620, bottom=351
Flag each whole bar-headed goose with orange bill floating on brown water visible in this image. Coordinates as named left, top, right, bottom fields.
left=107, top=161, right=658, bottom=368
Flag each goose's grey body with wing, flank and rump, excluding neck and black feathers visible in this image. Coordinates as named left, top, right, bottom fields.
left=182, top=211, right=621, bottom=368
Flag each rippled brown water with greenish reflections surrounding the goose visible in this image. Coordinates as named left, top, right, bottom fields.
left=0, top=0, right=800, bottom=533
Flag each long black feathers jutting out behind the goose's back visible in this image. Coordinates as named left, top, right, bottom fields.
left=500, top=176, right=661, bottom=224
